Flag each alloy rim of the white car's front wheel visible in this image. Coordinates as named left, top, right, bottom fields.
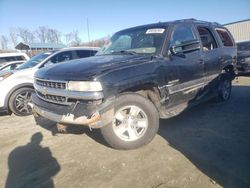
left=15, top=91, right=32, bottom=115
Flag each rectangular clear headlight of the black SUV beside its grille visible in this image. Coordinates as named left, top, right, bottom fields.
left=68, top=81, right=102, bottom=91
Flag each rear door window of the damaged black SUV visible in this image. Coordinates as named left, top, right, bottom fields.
left=197, top=27, right=218, bottom=51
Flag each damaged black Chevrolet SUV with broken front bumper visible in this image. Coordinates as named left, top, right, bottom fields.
left=32, top=19, right=237, bottom=149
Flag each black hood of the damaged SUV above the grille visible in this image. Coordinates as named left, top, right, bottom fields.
left=35, top=55, right=150, bottom=81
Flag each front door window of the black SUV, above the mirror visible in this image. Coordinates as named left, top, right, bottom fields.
left=170, top=25, right=196, bottom=46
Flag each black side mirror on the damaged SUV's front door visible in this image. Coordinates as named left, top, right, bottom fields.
left=170, top=40, right=201, bottom=55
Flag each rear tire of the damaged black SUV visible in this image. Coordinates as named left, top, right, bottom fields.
left=218, top=77, right=232, bottom=102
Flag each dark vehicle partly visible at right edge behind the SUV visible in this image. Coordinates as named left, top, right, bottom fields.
left=236, top=41, right=250, bottom=73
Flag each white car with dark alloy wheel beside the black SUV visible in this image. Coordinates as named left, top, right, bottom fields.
left=0, top=47, right=99, bottom=116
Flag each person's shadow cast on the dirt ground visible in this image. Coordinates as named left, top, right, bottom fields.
left=5, top=132, right=60, bottom=188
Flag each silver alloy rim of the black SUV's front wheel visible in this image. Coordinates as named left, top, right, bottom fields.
left=112, top=105, right=148, bottom=141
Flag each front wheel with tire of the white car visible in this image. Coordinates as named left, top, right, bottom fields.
left=9, top=87, right=34, bottom=116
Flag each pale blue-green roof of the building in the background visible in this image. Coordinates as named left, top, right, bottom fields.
left=16, top=42, right=66, bottom=50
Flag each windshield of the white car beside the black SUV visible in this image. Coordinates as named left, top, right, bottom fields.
left=17, top=52, right=53, bottom=70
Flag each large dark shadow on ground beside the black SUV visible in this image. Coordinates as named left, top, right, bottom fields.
left=159, top=86, right=250, bottom=188
